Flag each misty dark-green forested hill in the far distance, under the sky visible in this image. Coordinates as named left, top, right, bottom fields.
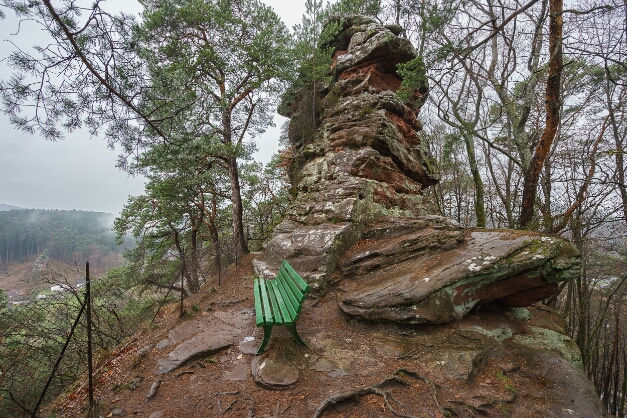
left=0, top=209, right=123, bottom=264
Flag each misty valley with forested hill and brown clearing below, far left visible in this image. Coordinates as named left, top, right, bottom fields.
left=0, top=204, right=133, bottom=303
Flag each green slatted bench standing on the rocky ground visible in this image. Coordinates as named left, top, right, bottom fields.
left=254, top=261, right=311, bottom=354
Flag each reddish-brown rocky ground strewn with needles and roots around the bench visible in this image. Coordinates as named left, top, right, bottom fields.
left=55, top=256, right=604, bottom=418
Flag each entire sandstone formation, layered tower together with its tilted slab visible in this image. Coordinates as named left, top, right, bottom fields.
left=255, top=17, right=579, bottom=323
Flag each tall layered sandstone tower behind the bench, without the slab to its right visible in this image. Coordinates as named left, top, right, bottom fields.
left=255, top=18, right=437, bottom=293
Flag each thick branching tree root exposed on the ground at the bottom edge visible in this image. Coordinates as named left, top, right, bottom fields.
left=314, top=369, right=447, bottom=418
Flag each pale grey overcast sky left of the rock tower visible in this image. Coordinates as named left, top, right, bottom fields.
left=0, top=0, right=305, bottom=214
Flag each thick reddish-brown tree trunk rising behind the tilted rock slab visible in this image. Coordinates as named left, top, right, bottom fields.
left=518, top=0, right=564, bottom=229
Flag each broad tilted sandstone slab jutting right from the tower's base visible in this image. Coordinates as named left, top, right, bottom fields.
left=337, top=216, right=579, bottom=323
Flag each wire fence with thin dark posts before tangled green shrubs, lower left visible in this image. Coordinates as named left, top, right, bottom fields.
left=0, top=263, right=182, bottom=418
